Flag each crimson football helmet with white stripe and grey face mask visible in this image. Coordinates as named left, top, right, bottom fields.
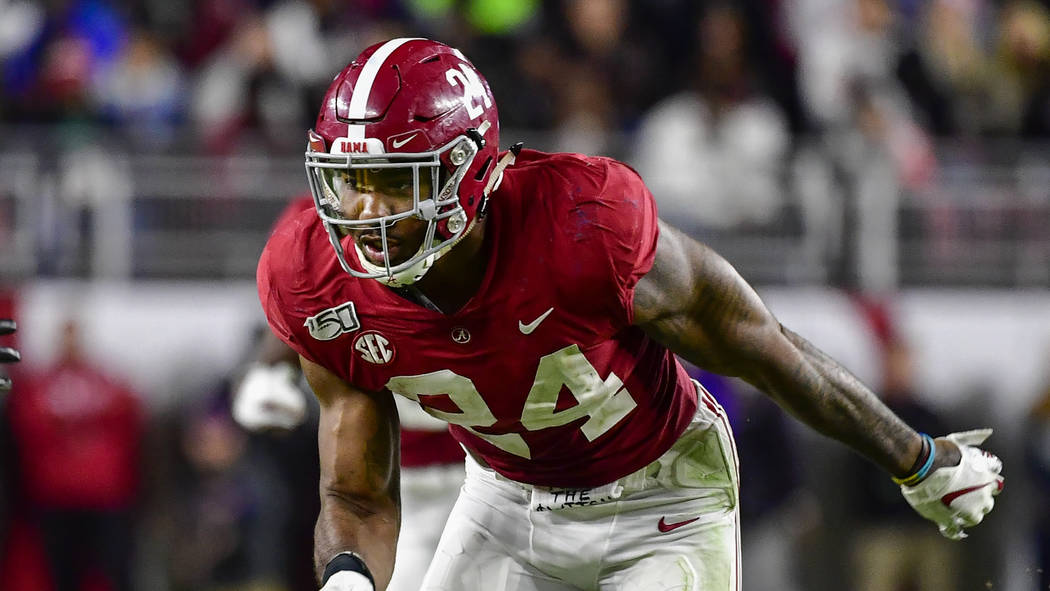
left=306, top=39, right=500, bottom=287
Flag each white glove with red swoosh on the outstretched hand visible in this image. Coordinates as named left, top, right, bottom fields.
left=901, top=428, right=1003, bottom=540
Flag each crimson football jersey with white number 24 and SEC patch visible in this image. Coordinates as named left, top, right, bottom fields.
left=257, top=150, right=697, bottom=487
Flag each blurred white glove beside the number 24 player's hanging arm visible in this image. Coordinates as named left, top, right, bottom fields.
left=233, top=362, right=307, bottom=430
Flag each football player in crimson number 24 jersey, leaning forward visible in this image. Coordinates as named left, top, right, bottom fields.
left=257, top=39, right=1003, bottom=591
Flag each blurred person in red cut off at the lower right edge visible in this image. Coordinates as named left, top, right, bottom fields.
left=1023, top=373, right=1050, bottom=589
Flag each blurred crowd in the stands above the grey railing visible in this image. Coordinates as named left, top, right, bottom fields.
left=0, top=0, right=1050, bottom=146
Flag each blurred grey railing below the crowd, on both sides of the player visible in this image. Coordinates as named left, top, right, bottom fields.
left=0, top=129, right=1050, bottom=289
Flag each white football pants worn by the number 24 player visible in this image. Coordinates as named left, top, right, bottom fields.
left=421, top=387, right=740, bottom=591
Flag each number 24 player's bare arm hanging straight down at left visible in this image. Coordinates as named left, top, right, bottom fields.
left=300, top=358, right=401, bottom=590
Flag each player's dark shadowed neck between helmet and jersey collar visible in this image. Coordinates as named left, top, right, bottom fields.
left=415, top=219, right=489, bottom=315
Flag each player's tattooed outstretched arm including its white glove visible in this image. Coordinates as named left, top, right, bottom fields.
left=634, top=223, right=1002, bottom=537
